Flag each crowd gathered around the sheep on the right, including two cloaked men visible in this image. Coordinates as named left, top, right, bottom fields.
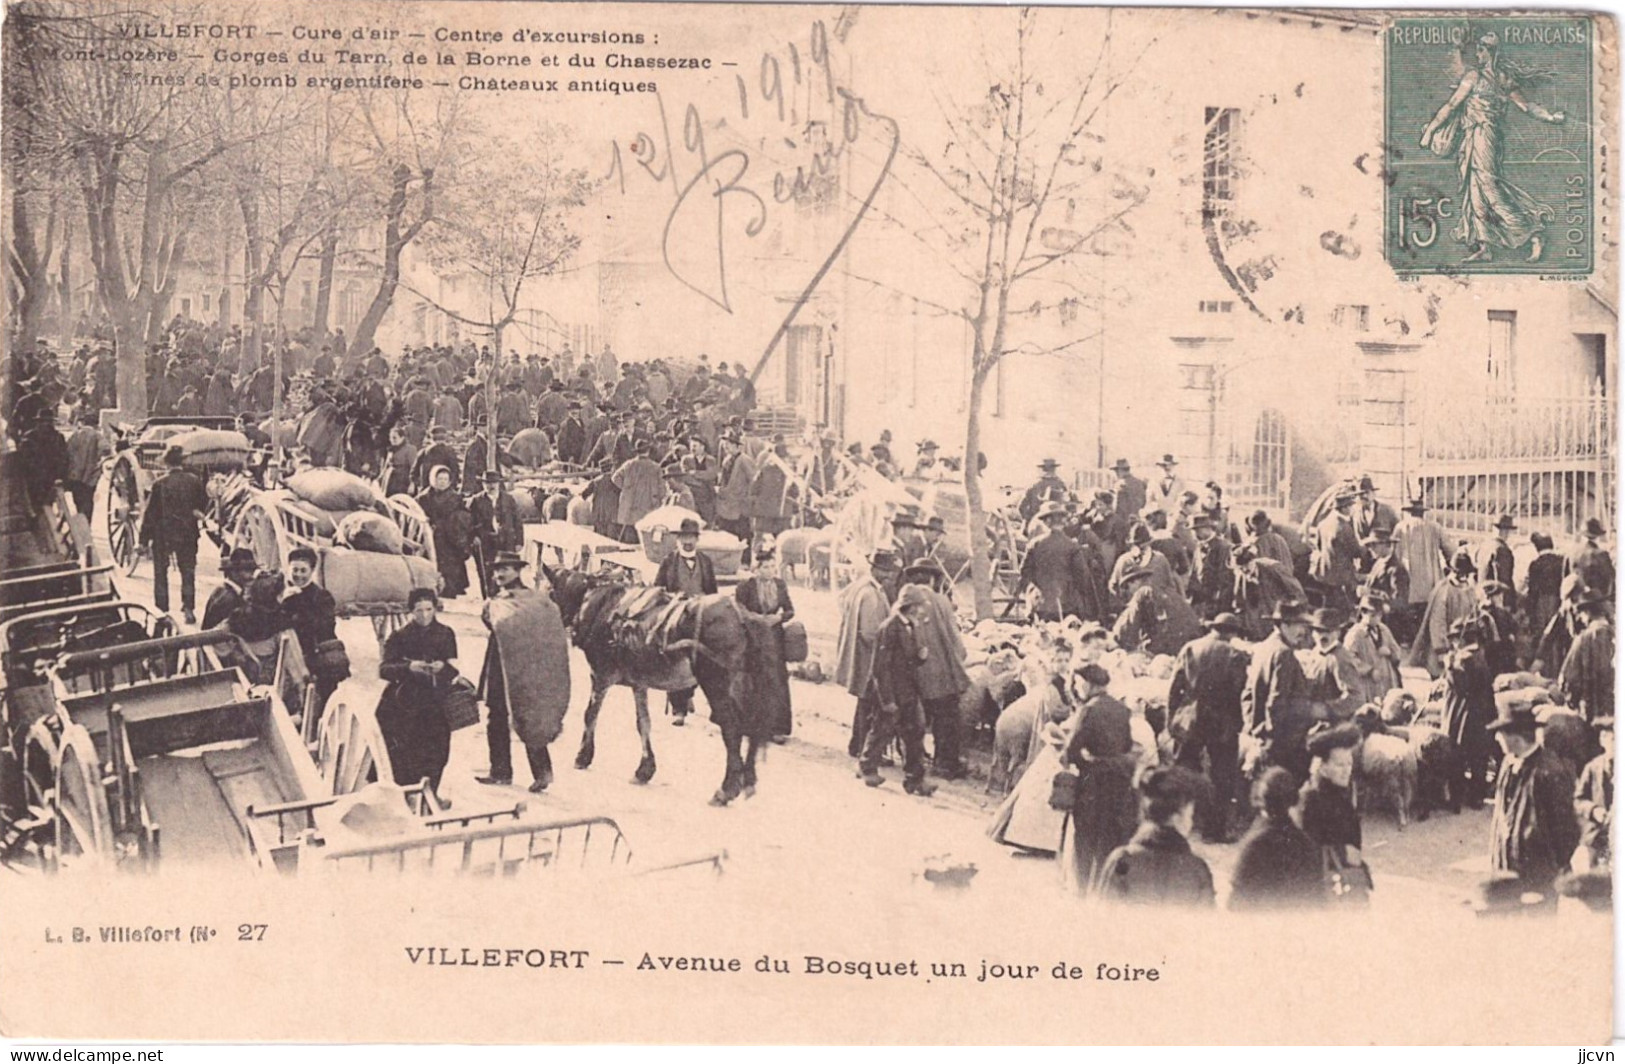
left=837, top=455, right=1614, bottom=908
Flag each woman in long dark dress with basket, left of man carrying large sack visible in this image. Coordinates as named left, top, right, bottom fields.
left=377, top=588, right=457, bottom=794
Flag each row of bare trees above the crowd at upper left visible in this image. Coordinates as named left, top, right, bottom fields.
left=0, top=0, right=588, bottom=416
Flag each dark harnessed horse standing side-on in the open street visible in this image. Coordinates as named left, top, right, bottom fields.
left=543, top=565, right=770, bottom=806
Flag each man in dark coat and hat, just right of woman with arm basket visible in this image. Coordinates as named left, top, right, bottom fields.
left=1168, top=612, right=1250, bottom=841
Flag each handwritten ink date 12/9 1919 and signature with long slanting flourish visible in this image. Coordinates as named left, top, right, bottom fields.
left=606, top=21, right=902, bottom=378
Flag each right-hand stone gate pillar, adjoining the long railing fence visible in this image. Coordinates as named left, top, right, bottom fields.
left=1359, top=340, right=1422, bottom=508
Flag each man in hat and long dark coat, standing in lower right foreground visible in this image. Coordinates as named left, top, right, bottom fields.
left=1489, top=702, right=1580, bottom=905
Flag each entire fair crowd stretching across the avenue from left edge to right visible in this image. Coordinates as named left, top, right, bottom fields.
left=7, top=322, right=1614, bottom=908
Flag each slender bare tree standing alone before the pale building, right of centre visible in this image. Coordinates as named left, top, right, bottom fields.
left=904, top=8, right=1149, bottom=617
